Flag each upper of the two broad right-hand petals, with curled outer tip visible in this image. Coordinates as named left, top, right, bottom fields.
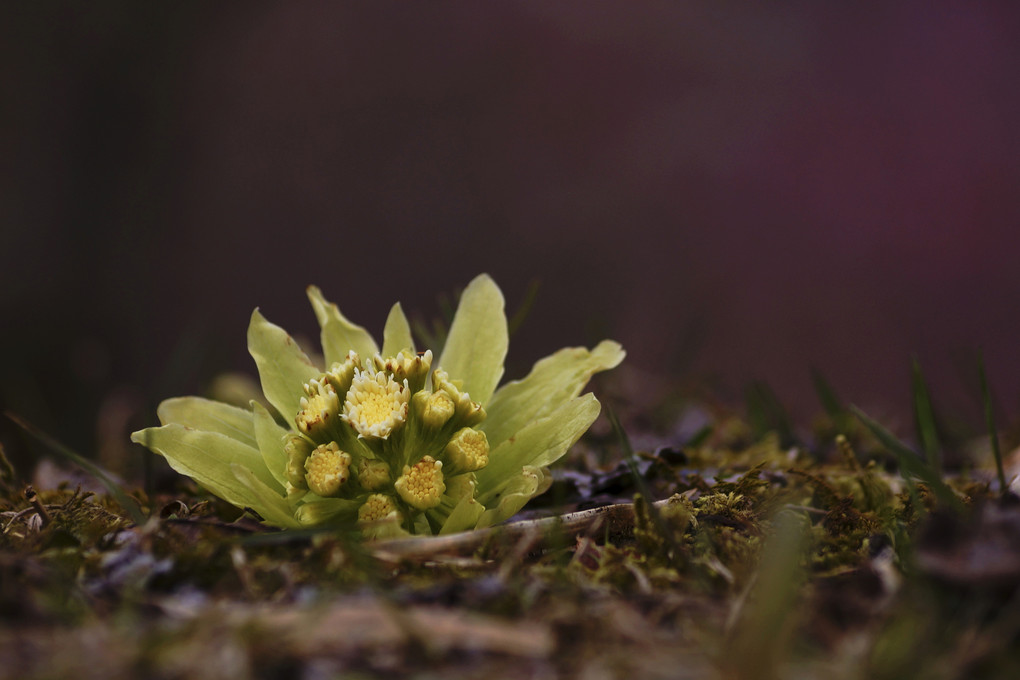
left=479, top=341, right=626, bottom=448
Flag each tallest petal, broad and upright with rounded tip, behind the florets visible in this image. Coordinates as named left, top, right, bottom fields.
left=439, top=274, right=509, bottom=406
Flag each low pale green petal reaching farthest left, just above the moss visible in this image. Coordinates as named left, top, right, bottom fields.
left=131, top=423, right=284, bottom=508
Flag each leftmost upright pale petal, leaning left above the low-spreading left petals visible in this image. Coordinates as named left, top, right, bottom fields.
left=248, top=309, right=320, bottom=422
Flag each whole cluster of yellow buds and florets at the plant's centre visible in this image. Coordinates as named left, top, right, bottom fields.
left=285, top=352, right=489, bottom=531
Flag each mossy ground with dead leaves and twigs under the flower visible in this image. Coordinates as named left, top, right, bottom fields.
left=0, top=387, right=1020, bottom=680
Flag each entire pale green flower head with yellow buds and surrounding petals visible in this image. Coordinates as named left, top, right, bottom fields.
left=132, top=274, right=624, bottom=537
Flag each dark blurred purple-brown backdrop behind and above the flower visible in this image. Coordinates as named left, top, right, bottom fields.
left=0, top=0, right=1020, bottom=477
